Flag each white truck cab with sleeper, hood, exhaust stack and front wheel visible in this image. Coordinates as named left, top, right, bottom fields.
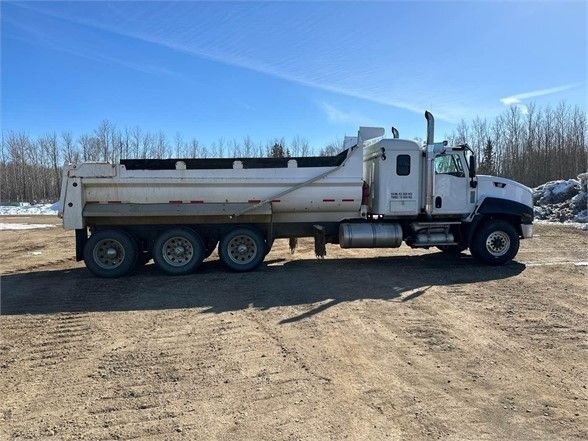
left=358, top=112, right=533, bottom=264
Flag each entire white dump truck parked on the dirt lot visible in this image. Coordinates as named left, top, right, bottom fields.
left=59, top=112, right=533, bottom=277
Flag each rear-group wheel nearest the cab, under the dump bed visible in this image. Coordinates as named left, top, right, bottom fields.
left=218, top=227, right=266, bottom=272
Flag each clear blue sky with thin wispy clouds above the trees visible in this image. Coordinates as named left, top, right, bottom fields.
left=1, top=1, right=587, bottom=146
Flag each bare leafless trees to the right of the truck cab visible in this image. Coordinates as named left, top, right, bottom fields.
left=448, top=103, right=588, bottom=187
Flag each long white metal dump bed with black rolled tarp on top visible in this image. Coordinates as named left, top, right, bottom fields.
left=61, top=146, right=363, bottom=229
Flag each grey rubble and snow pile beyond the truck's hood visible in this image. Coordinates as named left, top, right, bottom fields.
left=533, top=173, right=588, bottom=223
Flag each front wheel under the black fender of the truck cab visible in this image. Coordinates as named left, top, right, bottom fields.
left=470, top=221, right=519, bottom=265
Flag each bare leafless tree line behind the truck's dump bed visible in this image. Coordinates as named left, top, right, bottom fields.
left=0, top=124, right=343, bottom=202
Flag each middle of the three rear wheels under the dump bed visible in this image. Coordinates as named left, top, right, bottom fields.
left=153, top=228, right=205, bottom=276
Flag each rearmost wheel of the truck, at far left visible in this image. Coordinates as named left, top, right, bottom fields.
left=84, top=229, right=138, bottom=278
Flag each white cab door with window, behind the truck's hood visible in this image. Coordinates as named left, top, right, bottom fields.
left=433, top=152, right=468, bottom=215
